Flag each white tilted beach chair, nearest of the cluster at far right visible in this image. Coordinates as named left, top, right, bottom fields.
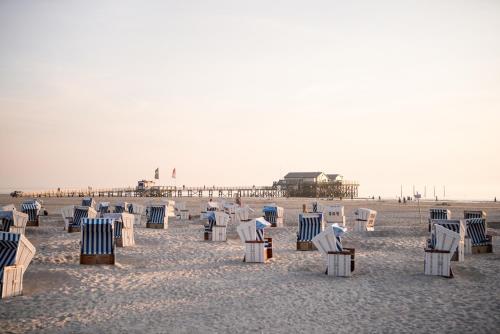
left=424, top=224, right=461, bottom=278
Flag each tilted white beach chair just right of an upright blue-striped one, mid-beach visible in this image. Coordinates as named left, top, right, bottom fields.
left=312, top=224, right=356, bottom=277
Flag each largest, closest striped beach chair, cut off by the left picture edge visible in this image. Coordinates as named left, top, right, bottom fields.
left=0, top=232, right=36, bottom=298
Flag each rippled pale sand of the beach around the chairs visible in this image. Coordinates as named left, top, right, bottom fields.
left=0, top=196, right=500, bottom=333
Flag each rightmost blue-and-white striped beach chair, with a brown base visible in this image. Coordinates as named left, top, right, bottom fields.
left=464, top=218, right=493, bottom=254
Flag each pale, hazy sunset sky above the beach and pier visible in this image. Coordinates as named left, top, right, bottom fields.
left=0, top=0, right=500, bottom=199
